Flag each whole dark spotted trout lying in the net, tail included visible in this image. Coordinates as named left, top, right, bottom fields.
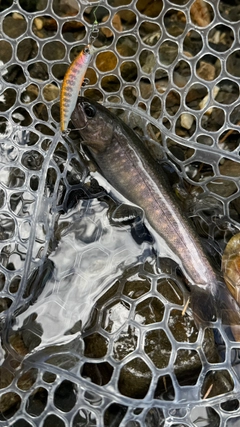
left=71, top=97, right=240, bottom=339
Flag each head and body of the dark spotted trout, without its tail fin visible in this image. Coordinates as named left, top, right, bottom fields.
left=72, top=97, right=215, bottom=286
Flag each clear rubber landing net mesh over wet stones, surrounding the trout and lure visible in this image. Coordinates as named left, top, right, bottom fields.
left=0, top=0, right=240, bottom=427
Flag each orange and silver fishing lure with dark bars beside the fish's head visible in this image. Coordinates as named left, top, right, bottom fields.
left=60, top=44, right=96, bottom=132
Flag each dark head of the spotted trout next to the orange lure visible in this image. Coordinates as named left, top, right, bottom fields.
left=71, top=96, right=115, bottom=154
